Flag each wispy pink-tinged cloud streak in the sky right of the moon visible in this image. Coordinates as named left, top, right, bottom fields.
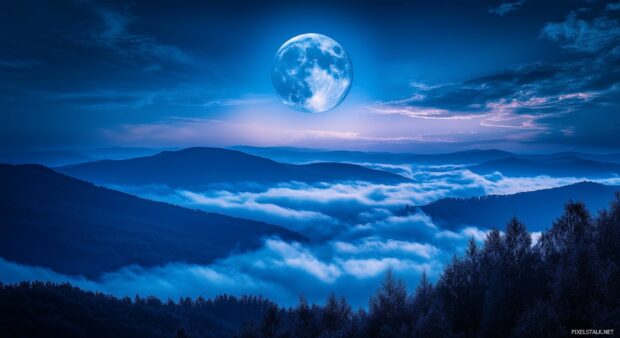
left=369, top=46, right=620, bottom=147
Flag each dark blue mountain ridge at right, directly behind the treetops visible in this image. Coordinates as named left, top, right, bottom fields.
left=416, top=182, right=620, bottom=231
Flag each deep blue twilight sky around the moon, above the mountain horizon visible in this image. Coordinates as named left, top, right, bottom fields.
left=0, top=0, right=620, bottom=152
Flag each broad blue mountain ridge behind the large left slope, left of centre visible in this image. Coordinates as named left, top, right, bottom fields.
left=57, top=148, right=408, bottom=188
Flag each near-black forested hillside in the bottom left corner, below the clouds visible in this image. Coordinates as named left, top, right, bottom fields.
left=0, top=282, right=272, bottom=338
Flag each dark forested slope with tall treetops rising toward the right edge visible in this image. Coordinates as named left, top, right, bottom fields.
left=241, top=194, right=620, bottom=337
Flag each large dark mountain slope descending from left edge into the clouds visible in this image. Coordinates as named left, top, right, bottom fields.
left=0, top=164, right=307, bottom=277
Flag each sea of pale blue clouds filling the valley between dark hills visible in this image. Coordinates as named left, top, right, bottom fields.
left=0, top=164, right=620, bottom=306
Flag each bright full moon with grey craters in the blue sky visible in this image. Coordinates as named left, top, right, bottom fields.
left=271, top=33, right=353, bottom=113
